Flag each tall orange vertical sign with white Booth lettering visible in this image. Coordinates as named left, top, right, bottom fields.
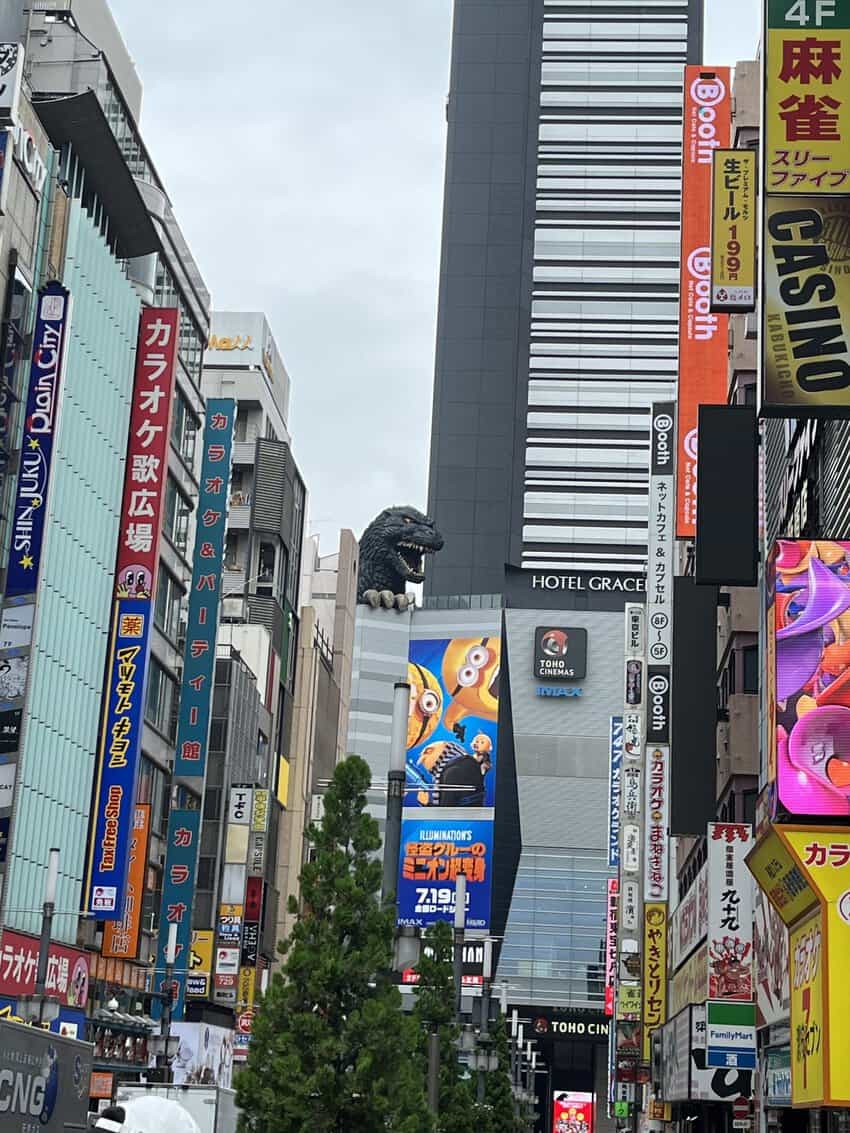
left=675, top=67, right=732, bottom=539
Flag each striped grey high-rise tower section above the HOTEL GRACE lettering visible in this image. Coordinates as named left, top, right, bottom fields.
left=426, top=0, right=703, bottom=595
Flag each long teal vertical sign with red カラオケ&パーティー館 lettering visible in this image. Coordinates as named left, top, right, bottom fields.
left=156, top=398, right=236, bottom=1020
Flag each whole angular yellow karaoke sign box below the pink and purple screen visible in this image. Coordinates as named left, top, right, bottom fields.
left=777, top=826, right=850, bottom=1106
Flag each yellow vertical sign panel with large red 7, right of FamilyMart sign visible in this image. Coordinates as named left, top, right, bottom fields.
left=790, top=909, right=825, bottom=1106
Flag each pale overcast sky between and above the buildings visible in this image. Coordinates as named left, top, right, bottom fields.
left=111, top=0, right=759, bottom=553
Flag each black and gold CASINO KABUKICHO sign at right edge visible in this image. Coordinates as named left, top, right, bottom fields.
left=762, top=197, right=850, bottom=416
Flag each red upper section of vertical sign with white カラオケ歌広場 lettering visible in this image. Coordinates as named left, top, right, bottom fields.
left=116, top=307, right=179, bottom=598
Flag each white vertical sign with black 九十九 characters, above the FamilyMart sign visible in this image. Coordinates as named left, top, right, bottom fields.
left=707, top=823, right=754, bottom=1002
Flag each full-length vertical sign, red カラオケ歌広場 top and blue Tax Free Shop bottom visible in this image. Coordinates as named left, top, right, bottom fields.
left=85, top=307, right=179, bottom=920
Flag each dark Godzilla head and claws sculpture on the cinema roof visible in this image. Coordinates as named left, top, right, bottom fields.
left=357, top=508, right=443, bottom=610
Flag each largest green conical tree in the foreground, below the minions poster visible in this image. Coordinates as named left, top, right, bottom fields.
left=236, top=756, right=431, bottom=1133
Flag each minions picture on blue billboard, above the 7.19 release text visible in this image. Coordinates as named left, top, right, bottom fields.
left=405, top=637, right=501, bottom=809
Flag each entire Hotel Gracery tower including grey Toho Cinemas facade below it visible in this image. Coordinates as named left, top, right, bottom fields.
left=425, top=0, right=703, bottom=1110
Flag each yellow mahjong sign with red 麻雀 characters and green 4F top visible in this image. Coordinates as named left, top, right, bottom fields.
left=765, top=0, right=850, bottom=196
